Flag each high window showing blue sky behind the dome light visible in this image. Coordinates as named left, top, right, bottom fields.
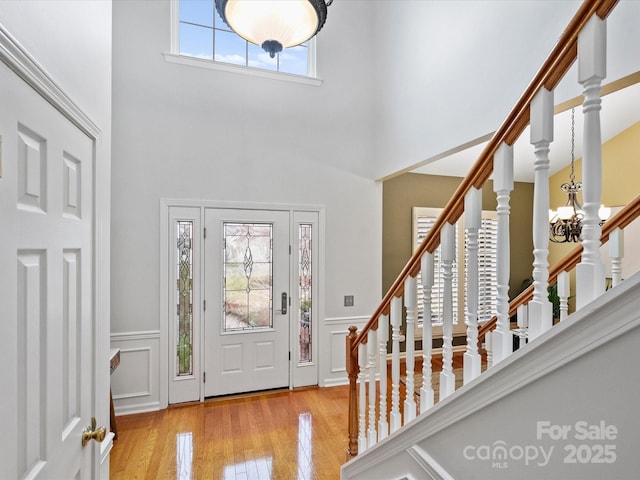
left=172, top=0, right=315, bottom=77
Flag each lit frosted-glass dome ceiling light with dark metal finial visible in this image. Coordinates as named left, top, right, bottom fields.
left=216, top=0, right=333, bottom=58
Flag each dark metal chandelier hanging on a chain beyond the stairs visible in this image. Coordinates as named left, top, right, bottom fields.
left=549, top=108, right=611, bottom=243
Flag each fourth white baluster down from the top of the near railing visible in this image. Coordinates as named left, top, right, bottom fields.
left=463, top=187, right=482, bottom=384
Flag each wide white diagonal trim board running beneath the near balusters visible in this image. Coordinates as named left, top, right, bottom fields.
left=342, top=273, right=640, bottom=478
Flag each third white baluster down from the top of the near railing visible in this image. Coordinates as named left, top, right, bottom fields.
left=492, top=143, right=513, bottom=364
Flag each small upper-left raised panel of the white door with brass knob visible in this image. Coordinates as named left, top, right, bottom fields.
left=17, top=125, right=47, bottom=212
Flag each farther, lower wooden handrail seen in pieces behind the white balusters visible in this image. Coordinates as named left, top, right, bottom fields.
left=478, top=195, right=640, bottom=341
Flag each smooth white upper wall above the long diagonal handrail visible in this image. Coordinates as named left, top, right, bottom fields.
left=372, top=0, right=640, bottom=178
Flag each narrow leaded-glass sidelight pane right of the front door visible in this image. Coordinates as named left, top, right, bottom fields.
left=298, top=224, right=312, bottom=363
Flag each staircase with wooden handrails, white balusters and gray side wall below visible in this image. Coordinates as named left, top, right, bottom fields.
left=342, top=0, right=640, bottom=480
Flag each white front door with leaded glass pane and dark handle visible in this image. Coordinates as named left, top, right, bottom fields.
left=204, top=208, right=291, bottom=397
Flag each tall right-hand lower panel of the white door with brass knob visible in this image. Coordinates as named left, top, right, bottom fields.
left=62, top=250, right=82, bottom=438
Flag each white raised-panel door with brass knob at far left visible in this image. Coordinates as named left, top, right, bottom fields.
left=0, top=55, right=97, bottom=479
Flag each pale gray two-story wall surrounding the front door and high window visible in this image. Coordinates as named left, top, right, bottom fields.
left=111, top=1, right=382, bottom=410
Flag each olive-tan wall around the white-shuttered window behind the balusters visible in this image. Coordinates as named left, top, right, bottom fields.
left=382, top=173, right=533, bottom=296
